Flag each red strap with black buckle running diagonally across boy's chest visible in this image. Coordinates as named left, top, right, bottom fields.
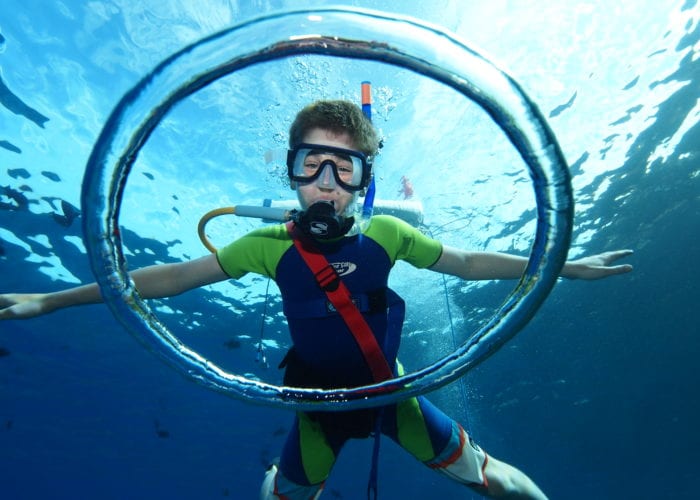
left=287, top=222, right=394, bottom=382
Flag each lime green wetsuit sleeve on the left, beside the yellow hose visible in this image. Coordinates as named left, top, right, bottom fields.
left=216, top=224, right=292, bottom=279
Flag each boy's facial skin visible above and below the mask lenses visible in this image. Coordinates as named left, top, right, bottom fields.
left=296, top=128, right=357, bottom=215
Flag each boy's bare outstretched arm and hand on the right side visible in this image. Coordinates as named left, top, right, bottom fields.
left=430, top=246, right=632, bottom=280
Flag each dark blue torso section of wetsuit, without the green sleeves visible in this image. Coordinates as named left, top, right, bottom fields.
left=276, top=230, right=403, bottom=387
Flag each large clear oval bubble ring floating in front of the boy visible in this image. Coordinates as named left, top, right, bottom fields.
left=82, top=8, right=573, bottom=411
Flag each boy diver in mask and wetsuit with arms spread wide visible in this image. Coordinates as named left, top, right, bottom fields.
left=0, top=101, right=632, bottom=500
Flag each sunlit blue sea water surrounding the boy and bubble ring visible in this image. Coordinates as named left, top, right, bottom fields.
left=0, top=0, right=700, bottom=499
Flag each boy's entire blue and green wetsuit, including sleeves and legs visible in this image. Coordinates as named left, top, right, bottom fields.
left=217, top=216, right=486, bottom=500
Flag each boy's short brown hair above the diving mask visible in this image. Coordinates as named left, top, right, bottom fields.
left=289, top=100, right=379, bottom=156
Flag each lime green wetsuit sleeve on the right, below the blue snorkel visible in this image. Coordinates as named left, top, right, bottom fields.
left=365, top=215, right=442, bottom=268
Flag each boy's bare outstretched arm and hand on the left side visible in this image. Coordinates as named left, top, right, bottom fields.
left=0, top=255, right=228, bottom=319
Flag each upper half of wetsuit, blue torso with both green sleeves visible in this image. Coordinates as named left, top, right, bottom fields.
left=218, top=216, right=441, bottom=387
